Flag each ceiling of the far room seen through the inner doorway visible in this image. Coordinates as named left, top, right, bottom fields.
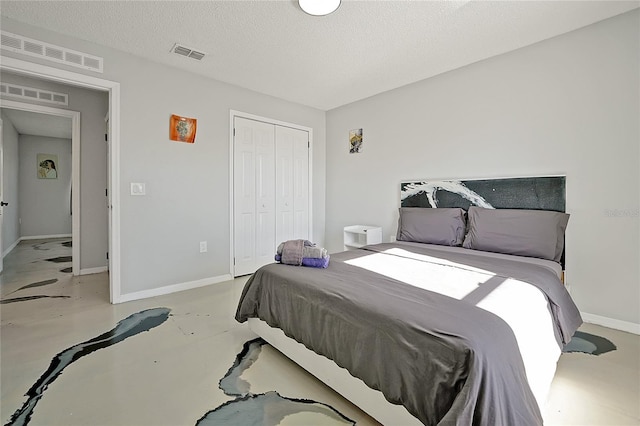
left=2, top=108, right=71, bottom=139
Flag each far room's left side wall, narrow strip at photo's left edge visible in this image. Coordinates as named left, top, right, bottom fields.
left=0, top=112, right=20, bottom=255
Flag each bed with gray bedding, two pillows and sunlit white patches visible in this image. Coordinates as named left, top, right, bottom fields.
left=236, top=175, right=582, bottom=425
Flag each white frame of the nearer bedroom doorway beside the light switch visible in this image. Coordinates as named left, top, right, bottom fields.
left=0, top=55, right=122, bottom=303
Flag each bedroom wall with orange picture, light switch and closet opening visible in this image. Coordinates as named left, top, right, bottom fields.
left=2, top=18, right=325, bottom=294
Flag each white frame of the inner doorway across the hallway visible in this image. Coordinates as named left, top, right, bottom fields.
left=0, top=99, right=81, bottom=275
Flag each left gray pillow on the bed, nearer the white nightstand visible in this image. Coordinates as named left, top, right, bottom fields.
left=396, top=207, right=466, bottom=246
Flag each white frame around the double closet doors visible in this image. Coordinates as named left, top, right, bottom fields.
left=229, top=109, right=313, bottom=278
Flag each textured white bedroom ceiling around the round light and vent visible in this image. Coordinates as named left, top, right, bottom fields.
left=1, top=0, right=640, bottom=110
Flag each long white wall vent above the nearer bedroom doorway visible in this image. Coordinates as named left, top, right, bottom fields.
left=1, top=31, right=103, bottom=73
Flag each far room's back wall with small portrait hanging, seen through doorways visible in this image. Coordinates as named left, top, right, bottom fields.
left=18, top=135, right=71, bottom=237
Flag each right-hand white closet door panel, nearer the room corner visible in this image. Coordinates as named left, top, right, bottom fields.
left=276, top=126, right=309, bottom=243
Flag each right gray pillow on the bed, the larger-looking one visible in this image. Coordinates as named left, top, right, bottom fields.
left=462, top=206, right=569, bottom=262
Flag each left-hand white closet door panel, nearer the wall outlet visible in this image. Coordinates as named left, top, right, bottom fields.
left=233, top=117, right=276, bottom=276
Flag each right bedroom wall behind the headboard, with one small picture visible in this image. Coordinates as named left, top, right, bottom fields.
left=326, top=10, right=640, bottom=330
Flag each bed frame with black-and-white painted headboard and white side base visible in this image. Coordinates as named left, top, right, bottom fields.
left=248, top=176, right=565, bottom=426
